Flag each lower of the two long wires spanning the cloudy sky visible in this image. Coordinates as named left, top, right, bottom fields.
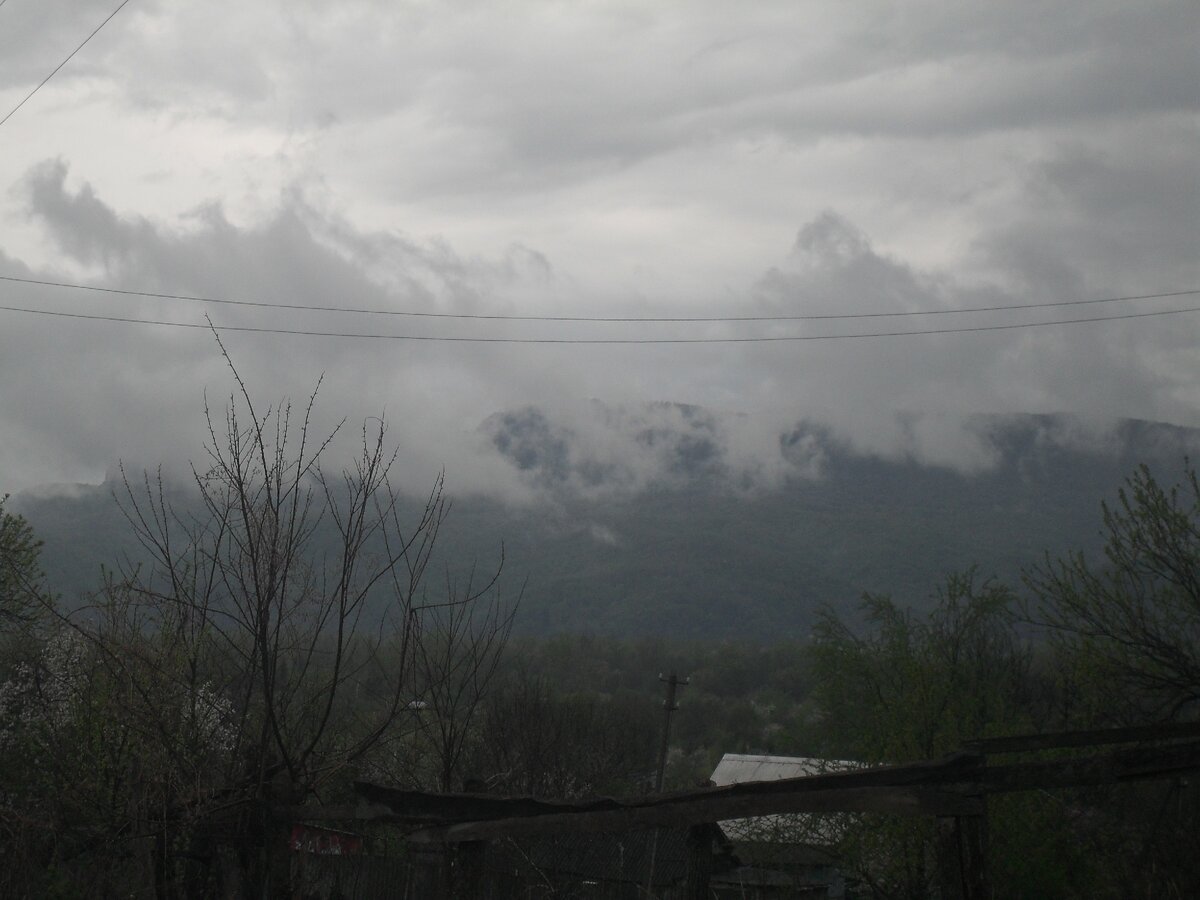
left=0, top=306, right=1200, bottom=344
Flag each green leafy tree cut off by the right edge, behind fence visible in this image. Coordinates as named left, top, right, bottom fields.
left=1024, top=461, right=1200, bottom=896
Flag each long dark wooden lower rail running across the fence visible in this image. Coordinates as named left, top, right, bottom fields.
left=281, top=742, right=1200, bottom=842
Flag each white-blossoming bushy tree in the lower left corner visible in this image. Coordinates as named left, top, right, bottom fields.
left=0, top=628, right=178, bottom=896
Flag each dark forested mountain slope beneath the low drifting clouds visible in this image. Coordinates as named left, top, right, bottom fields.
left=13, top=416, right=1200, bottom=640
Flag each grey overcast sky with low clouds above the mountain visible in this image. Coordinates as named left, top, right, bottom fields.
left=0, top=0, right=1200, bottom=493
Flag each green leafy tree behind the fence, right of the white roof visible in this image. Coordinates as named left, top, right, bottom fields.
left=806, top=570, right=1082, bottom=900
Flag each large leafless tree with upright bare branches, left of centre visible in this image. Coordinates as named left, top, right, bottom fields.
left=44, top=341, right=511, bottom=896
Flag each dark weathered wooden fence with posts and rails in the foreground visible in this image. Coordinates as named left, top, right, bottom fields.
left=290, top=722, right=1200, bottom=900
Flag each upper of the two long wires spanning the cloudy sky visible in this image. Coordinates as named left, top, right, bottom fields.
left=0, top=275, right=1200, bottom=324
